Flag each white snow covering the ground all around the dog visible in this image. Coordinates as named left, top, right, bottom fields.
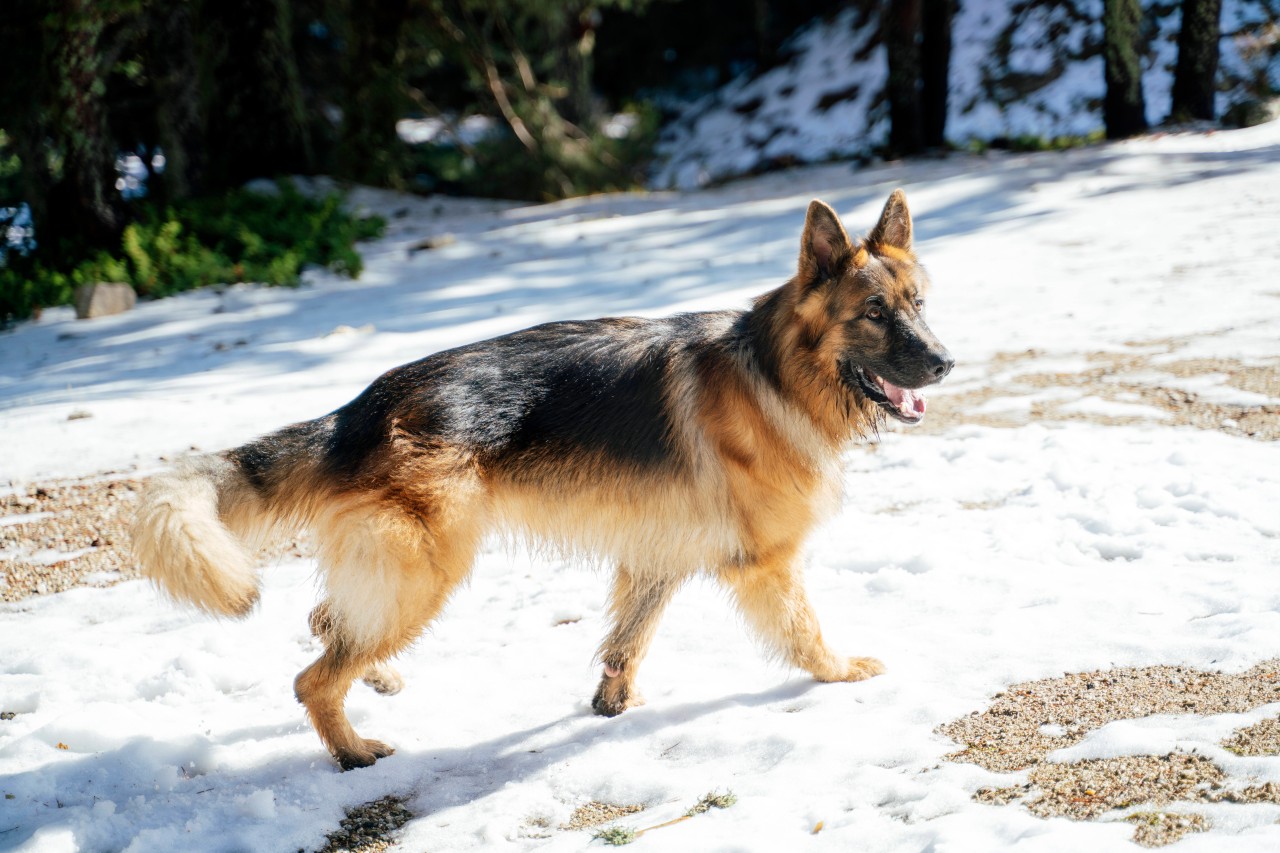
left=0, top=124, right=1280, bottom=853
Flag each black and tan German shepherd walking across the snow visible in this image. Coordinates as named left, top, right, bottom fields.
left=133, top=190, right=952, bottom=768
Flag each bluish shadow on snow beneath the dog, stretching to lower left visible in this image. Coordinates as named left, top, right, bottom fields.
left=0, top=679, right=818, bottom=850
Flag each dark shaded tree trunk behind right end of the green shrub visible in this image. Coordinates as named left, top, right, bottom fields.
left=337, top=0, right=410, bottom=190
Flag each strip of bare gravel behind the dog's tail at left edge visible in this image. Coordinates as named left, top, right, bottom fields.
left=0, top=474, right=306, bottom=602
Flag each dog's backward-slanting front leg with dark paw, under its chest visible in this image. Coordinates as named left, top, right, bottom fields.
left=591, top=566, right=689, bottom=717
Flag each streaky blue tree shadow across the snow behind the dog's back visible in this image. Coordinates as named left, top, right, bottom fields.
left=0, top=135, right=1280, bottom=419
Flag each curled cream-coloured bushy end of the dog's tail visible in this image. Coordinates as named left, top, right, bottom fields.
left=133, top=456, right=296, bottom=616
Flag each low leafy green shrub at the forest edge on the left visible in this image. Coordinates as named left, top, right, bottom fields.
left=0, top=181, right=385, bottom=323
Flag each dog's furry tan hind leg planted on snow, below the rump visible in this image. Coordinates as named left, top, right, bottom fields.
left=294, top=484, right=480, bottom=770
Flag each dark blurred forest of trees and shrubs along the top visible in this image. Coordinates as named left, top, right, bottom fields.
left=0, top=0, right=1280, bottom=323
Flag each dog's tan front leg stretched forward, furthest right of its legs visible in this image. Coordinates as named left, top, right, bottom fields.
left=718, top=549, right=884, bottom=681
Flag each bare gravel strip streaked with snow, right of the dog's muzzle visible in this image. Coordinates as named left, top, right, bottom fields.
left=922, top=341, right=1280, bottom=441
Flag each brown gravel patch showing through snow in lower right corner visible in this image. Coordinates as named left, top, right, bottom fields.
left=938, top=658, right=1280, bottom=847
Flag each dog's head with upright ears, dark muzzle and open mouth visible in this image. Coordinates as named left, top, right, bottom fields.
left=792, top=190, right=954, bottom=424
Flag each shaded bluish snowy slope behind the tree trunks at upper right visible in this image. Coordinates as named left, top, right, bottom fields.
left=652, top=0, right=1280, bottom=188
